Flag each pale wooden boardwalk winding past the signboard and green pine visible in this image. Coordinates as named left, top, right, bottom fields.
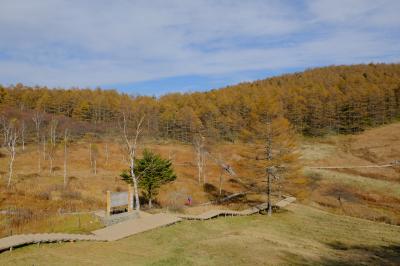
left=0, top=197, right=296, bottom=252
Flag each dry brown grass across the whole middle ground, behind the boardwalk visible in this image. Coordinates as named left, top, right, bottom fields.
left=0, top=123, right=400, bottom=234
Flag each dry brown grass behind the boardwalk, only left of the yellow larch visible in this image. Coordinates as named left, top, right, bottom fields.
left=0, top=139, right=256, bottom=235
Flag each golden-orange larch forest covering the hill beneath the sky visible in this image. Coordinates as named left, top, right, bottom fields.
left=0, top=64, right=400, bottom=141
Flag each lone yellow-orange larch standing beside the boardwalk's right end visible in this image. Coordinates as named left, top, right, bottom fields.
left=242, top=94, right=299, bottom=215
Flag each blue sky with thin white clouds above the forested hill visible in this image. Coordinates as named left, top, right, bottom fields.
left=0, top=0, right=400, bottom=95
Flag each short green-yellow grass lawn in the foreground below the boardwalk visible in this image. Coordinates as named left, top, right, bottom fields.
left=0, top=204, right=400, bottom=265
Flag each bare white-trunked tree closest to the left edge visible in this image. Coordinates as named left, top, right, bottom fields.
left=1, top=117, right=18, bottom=188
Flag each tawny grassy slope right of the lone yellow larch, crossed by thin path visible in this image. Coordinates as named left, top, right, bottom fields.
left=300, top=123, right=400, bottom=225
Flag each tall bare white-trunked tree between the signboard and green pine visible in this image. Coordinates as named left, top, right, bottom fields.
left=122, top=112, right=144, bottom=211
